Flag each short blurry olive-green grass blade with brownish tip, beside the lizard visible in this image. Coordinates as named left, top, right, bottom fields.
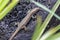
left=32, top=15, right=42, bottom=40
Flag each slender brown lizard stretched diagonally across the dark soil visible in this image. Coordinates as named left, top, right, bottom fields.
left=9, top=7, right=40, bottom=40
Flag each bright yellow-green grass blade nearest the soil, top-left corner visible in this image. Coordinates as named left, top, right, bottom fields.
left=0, top=0, right=19, bottom=20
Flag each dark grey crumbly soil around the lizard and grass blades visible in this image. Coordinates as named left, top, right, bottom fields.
left=0, top=0, right=60, bottom=40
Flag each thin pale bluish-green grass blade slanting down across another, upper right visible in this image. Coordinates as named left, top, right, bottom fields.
left=30, top=0, right=60, bottom=20
